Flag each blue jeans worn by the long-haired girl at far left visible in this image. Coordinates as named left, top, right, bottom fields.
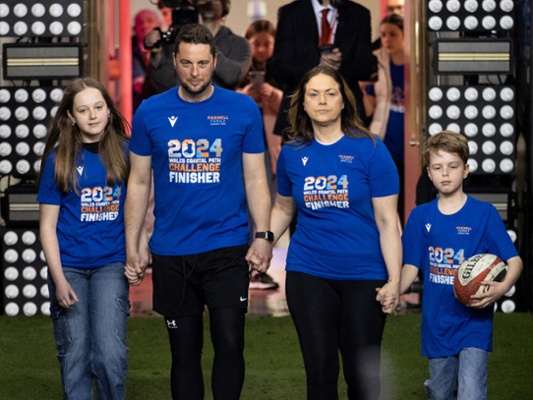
left=48, top=263, right=130, bottom=400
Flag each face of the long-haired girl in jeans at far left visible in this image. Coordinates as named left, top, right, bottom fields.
left=67, top=87, right=110, bottom=143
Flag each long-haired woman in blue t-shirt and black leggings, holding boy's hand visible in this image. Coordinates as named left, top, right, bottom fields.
left=271, top=66, right=401, bottom=400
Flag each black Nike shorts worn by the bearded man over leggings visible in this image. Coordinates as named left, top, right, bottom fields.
left=152, top=244, right=250, bottom=317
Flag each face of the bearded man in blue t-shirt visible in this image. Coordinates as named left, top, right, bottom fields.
left=174, top=43, right=216, bottom=101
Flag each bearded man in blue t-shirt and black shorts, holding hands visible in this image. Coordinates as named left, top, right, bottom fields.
left=125, top=24, right=272, bottom=400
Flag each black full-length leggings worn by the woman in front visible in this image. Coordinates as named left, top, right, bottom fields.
left=286, top=271, right=385, bottom=400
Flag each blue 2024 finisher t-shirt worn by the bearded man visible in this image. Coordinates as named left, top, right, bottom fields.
left=130, top=86, right=265, bottom=256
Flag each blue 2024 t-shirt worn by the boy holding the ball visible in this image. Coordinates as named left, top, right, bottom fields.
left=402, top=196, right=518, bottom=358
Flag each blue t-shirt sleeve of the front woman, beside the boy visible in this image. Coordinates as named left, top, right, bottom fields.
left=368, top=138, right=400, bottom=198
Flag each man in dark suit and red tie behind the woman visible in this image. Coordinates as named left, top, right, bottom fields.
left=269, top=0, right=377, bottom=135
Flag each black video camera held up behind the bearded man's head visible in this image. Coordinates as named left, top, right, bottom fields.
left=144, top=0, right=198, bottom=50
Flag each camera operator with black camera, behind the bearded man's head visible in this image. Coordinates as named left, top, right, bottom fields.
left=141, top=0, right=252, bottom=95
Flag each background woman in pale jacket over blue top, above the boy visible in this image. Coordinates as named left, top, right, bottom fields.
left=363, top=14, right=405, bottom=222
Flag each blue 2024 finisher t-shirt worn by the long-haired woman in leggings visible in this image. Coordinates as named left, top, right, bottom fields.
left=277, top=136, right=399, bottom=280
